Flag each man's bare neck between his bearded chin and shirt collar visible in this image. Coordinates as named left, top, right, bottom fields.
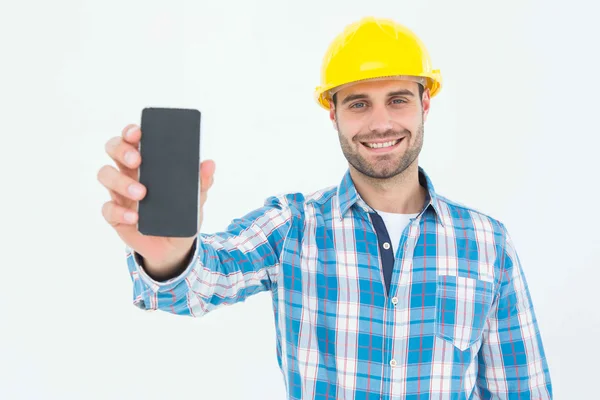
left=350, top=162, right=427, bottom=214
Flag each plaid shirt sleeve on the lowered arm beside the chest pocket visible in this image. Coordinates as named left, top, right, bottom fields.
left=476, top=226, right=552, bottom=400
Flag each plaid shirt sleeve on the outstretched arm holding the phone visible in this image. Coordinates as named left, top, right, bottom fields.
left=126, top=196, right=292, bottom=317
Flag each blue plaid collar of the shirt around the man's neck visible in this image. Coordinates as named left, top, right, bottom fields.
left=337, top=166, right=444, bottom=226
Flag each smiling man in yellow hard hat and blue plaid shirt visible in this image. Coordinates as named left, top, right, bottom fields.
left=99, top=18, right=552, bottom=399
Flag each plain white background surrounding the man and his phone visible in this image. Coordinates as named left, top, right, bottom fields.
left=0, top=0, right=600, bottom=400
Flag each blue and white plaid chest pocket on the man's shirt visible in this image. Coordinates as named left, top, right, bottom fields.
left=435, top=275, right=494, bottom=351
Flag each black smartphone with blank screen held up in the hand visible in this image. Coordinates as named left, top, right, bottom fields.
left=138, top=107, right=200, bottom=237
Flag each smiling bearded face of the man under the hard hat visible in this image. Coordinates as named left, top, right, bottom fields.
left=330, top=80, right=430, bottom=179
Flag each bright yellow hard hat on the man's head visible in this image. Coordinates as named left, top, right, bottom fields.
left=314, top=17, right=442, bottom=110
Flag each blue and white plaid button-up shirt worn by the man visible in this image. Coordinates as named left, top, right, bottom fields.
left=127, top=167, right=552, bottom=400
